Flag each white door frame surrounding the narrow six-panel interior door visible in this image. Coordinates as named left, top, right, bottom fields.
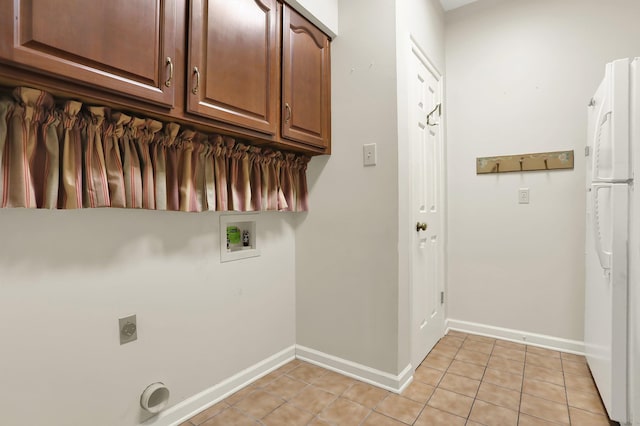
left=404, top=37, right=447, bottom=369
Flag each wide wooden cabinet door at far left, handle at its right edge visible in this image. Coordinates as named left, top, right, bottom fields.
left=0, top=0, right=176, bottom=106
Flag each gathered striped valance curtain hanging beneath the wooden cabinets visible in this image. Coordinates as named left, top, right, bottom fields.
left=0, top=87, right=309, bottom=212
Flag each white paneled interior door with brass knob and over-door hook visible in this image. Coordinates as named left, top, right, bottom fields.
left=407, top=48, right=444, bottom=366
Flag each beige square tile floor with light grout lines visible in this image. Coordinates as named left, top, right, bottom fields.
left=181, top=331, right=610, bottom=426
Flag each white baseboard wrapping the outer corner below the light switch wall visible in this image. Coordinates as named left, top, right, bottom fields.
left=296, top=345, right=413, bottom=393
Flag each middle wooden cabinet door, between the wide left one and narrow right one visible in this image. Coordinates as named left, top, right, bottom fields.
left=187, top=0, right=279, bottom=134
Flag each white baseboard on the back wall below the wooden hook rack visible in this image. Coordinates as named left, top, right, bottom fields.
left=445, top=318, right=584, bottom=355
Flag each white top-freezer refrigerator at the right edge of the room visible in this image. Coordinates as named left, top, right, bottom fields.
left=584, top=58, right=640, bottom=425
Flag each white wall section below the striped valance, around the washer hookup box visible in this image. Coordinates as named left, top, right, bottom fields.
left=0, top=209, right=295, bottom=426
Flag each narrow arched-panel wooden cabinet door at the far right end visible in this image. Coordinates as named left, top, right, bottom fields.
left=282, top=6, right=331, bottom=149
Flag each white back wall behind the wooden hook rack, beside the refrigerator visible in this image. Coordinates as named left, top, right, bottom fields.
left=445, top=0, right=640, bottom=341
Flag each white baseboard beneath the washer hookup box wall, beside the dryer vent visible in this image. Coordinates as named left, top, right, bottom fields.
left=142, top=345, right=296, bottom=426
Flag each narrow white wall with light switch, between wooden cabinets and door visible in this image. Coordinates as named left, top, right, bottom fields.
left=296, top=0, right=398, bottom=372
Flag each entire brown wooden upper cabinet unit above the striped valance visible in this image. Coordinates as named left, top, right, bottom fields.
left=0, top=0, right=331, bottom=155
